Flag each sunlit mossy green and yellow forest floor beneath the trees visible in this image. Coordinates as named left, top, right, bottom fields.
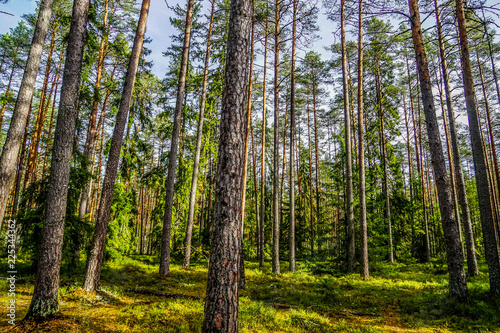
left=0, top=256, right=500, bottom=332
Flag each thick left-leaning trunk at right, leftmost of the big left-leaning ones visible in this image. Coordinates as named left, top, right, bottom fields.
left=408, top=0, right=468, bottom=301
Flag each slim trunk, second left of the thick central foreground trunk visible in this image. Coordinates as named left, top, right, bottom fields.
left=160, top=0, right=194, bottom=276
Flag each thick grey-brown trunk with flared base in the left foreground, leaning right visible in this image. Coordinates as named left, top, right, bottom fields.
left=25, top=0, right=89, bottom=318
